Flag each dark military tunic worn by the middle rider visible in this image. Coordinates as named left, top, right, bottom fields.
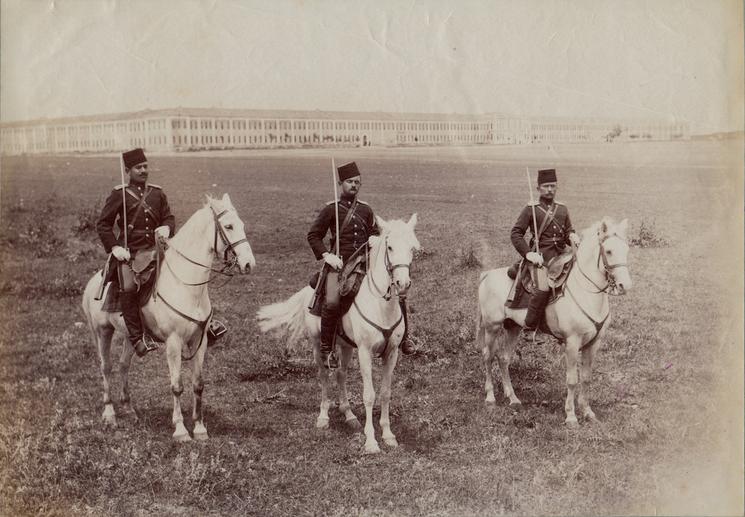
left=308, top=197, right=380, bottom=262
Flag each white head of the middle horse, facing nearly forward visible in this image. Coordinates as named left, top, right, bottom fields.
left=376, top=214, right=421, bottom=296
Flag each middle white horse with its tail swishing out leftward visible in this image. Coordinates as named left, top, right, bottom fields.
left=257, top=214, right=420, bottom=453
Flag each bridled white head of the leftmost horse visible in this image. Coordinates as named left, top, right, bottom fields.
left=207, top=194, right=256, bottom=273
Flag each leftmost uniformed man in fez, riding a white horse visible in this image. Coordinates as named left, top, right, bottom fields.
left=96, top=148, right=176, bottom=357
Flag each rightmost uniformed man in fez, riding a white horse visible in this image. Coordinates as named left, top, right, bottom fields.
left=510, top=169, right=579, bottom=344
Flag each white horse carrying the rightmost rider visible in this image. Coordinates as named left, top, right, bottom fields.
left=476, top=218, right=631, bottom=427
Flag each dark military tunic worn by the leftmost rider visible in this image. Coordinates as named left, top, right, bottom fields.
left=96, top=183, right=176, bottom=253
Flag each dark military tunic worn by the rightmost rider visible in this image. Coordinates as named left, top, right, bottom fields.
left=510, top=201, right=574, bottom=262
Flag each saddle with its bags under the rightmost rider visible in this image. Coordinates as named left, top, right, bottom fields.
left=506, top=247, right=575, bottom=309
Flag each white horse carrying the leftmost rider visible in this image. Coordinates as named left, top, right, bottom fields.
left=83, top=194, right=256, bottom=441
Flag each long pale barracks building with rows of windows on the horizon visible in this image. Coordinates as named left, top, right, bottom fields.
left=0, top=108, right=690, bottom=155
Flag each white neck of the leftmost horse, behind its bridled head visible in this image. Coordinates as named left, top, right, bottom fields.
left=166, top=206, right=214, bottom=289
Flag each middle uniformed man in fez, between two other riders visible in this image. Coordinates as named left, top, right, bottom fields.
left=308, top=162, right=413, bottom=369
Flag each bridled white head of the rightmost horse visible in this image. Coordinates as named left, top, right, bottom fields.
left=580, top=217, right=632, bottom=294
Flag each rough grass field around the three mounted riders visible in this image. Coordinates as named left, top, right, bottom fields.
left=0, top=142, right=743, bottom=515
